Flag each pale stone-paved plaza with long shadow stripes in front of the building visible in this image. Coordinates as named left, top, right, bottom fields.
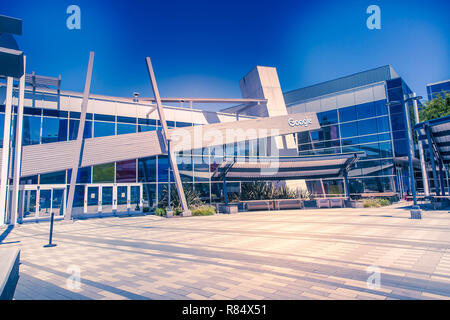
left=0, top=207, right=450, bottom=300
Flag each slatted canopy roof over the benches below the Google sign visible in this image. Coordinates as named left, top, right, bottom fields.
left=212, top=153, right=364, bottom=181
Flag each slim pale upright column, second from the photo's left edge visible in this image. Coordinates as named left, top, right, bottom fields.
left=11, top=56, right=26, bottom=224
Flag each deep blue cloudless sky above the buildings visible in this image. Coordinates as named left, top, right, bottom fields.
left=0, top=0, right=450, bottom=110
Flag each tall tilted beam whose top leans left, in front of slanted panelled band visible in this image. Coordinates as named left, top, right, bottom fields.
left=146, top=57, right=191, bottom=216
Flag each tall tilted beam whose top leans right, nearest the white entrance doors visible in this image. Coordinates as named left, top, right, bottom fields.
left=64, top=51, right=95, bottom=220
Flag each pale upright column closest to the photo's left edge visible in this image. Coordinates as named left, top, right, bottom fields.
left=0, top=77, right=13, bottom=226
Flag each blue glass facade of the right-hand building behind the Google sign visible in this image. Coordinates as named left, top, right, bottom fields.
left=288, top=78, right=414, bottom=194
